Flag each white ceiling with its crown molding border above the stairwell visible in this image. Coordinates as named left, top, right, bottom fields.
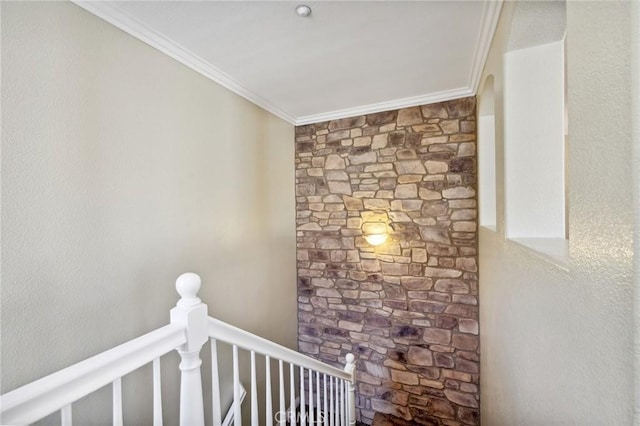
left=70, top=0, right=501, bottom=124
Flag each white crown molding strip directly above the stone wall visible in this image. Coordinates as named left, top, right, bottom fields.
left=294, top=87, right=475, bottom=126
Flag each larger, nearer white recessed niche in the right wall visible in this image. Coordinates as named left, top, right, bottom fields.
left=504, top=2, right=567, bottom=257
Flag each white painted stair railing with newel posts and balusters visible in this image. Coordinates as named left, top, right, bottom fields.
left=0, top=272, right=355, bottom=426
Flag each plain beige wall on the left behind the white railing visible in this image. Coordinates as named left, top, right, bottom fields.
left=1, top=2, right=296, bottom=424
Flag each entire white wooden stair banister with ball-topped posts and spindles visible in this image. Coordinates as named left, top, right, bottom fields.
left=0, top=273, right=356, bottom=426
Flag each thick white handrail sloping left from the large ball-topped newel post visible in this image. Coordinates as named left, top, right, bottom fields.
left=0, top=324, right=187, bottom=424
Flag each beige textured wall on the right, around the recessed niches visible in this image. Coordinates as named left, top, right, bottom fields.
left=480, top=2, right=638, bottom=426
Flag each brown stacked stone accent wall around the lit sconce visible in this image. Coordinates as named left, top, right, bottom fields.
left=296, top=97, right=479, bottom=425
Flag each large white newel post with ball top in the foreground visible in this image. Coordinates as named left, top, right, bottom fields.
left=171, top=272, right=208, bottom=426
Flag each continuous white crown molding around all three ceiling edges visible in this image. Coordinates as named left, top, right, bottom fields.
left=71, top=0, right=503, bottom=126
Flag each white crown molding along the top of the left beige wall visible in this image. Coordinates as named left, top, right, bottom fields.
left=71, top=0, right=296, bottom=124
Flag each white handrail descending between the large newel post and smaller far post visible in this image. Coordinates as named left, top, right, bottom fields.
left=208, top=317, right=353, bottom=381
